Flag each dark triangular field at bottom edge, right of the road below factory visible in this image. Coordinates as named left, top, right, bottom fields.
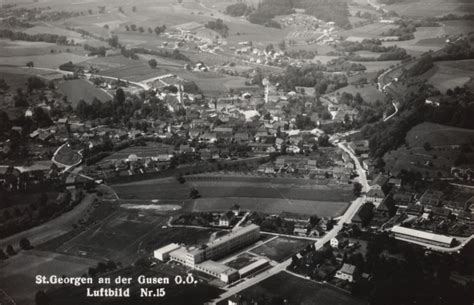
left=224, top=271, right=364, bottom=305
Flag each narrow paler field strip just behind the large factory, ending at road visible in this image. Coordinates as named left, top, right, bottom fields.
left=191, top=197, right=349, bottom=217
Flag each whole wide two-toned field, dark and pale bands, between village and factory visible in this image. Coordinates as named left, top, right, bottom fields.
left=113, top=177, right=352, bottom=217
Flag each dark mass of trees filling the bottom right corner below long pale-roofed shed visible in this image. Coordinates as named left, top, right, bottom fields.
left=352, top=233, right=473, bottom=305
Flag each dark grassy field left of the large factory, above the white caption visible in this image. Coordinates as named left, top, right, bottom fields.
left=55, top=209, right=215, bottom=263
